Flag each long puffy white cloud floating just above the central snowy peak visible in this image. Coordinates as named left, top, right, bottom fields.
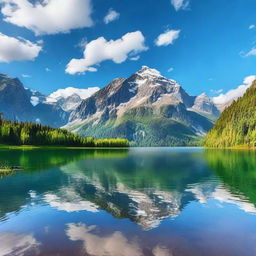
left=66, top=31, right=148, bottom=74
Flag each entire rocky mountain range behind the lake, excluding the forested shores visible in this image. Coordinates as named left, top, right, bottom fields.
left=0, top=66, right=248, bottom=146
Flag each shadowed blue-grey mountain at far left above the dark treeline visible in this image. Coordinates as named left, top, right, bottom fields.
left=0, top=74, right=69, bottom=127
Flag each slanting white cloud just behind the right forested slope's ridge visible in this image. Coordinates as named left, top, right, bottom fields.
left=212, top=76, right=256, bottom=105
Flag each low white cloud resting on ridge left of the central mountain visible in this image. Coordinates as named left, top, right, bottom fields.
left=47, top=87, right=100, bottom=102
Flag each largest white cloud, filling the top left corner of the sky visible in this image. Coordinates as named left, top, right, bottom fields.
left=0, top=0, right=93, bottom=35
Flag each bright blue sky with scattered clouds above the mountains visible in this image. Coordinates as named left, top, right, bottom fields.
left=0, top=0, right=256, bottom=95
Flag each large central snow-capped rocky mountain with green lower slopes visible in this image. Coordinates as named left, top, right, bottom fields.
left=65, top=66, right=218, bottom=146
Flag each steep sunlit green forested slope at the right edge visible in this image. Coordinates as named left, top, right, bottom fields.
left=205, top=80, right=256, bottom=147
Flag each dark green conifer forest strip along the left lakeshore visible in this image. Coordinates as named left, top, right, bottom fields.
left=0, top=117, right=129, bottom=147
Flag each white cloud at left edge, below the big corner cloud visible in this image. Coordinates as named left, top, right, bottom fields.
left=0, top=33, right=42, bottom=63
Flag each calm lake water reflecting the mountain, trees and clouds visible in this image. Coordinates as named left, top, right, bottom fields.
left=0, top=148, right=256, bottom=256
